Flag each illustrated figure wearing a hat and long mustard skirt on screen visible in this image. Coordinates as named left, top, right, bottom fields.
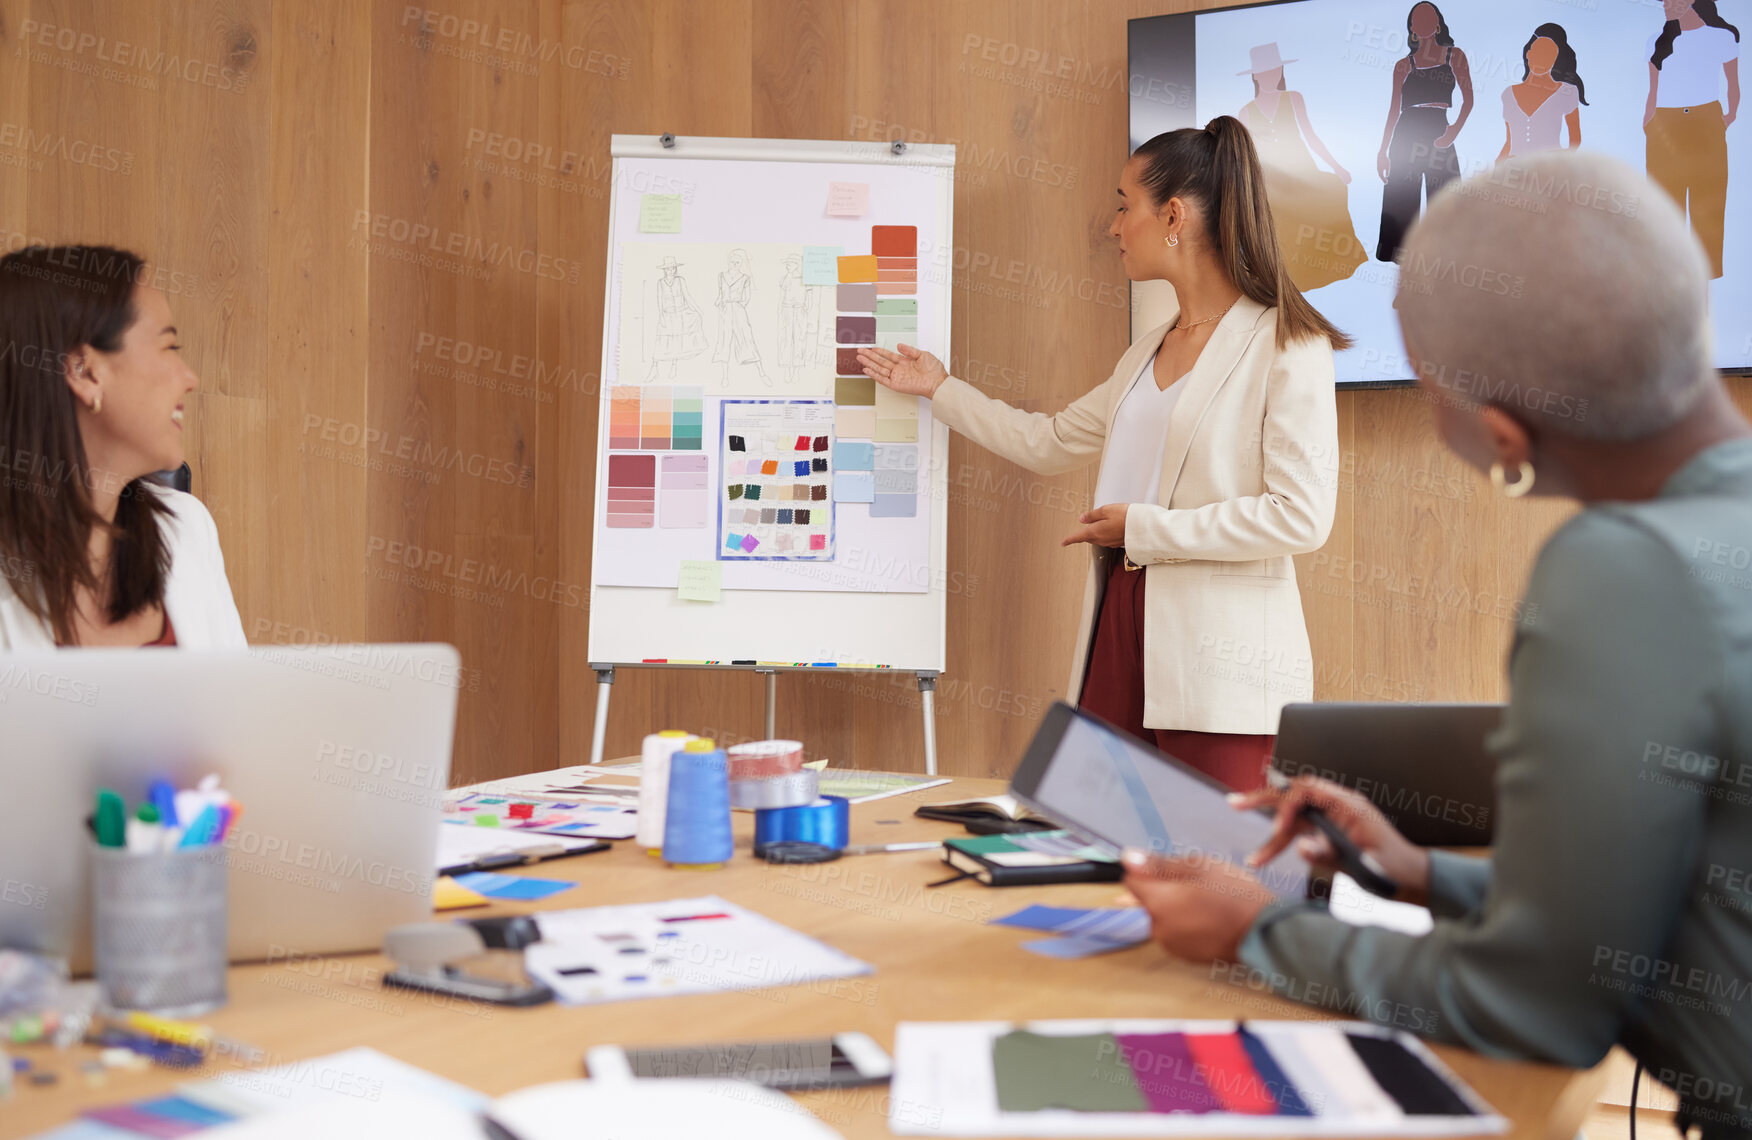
left=1239, top=44, right=1368, bottom=292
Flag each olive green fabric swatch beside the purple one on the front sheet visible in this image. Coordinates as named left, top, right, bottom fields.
left=992, top=1030, right=1149, bottom=1112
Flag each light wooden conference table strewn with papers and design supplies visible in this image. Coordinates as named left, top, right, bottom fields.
left=10, top=779, right=1598, bottom=1140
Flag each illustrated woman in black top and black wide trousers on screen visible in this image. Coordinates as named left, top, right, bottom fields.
left=1375, top=0, right=1472, bottom=261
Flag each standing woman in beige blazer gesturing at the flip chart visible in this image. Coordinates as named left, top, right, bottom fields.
left=858, top=116, right=1351, bottom=788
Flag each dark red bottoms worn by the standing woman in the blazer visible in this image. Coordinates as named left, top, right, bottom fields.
left=1077, top=552, right=1277, bottom=792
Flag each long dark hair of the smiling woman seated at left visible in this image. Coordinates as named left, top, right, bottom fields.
left=0, top=245, right=170, bottom=644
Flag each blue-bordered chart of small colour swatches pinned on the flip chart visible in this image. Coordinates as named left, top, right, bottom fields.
left=718, top=399, right=837, bottom=562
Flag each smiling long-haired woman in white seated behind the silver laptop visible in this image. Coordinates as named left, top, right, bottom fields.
left=0, top=245, right=245, bottom=651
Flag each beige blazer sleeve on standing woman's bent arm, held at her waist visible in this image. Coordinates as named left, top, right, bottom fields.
left=1125, top=332, right=1339, bottom=562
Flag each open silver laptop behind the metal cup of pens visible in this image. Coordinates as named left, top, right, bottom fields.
left=0, top=644, right=459, bottom=972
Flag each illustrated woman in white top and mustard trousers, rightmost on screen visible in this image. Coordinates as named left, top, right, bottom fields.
left=1643, top=0, right=1740, bottom=278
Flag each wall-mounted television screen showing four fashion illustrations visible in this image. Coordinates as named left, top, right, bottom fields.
left=1128, top=0, right=1752, bottom=387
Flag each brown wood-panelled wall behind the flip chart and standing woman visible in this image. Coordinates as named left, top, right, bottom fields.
left=0, top=0, right=1695, bottom=778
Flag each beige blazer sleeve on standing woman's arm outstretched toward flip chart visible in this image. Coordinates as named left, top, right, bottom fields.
left=930, top=365, right=1132, bottom=475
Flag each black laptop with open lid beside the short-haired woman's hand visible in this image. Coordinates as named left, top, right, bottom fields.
left=1272, top=700, right=1503, bottom=848
